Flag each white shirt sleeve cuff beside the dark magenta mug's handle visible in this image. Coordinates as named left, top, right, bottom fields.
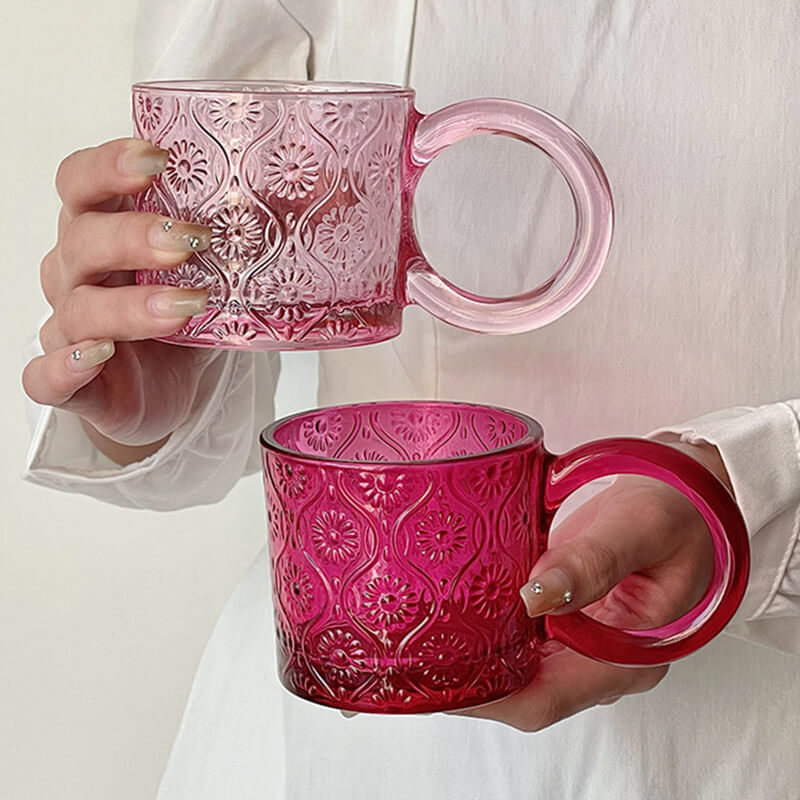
left=652, top=400, right=800, bottom=652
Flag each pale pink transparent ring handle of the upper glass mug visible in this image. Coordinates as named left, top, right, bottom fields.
left=403, top=98, right=614, bottom=334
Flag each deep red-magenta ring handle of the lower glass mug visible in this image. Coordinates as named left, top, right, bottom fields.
left=544, top=438, right=750, bottom=666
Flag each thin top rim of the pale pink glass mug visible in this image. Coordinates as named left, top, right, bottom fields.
left=131, top=79, right=414, bottom=97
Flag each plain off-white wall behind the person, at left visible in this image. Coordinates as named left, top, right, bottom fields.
left=0, top=0, right=310, bottom=800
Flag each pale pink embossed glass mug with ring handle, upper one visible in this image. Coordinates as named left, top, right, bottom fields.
left=133, top=81, right=613, bottom=350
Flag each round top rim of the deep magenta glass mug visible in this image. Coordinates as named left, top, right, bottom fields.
left=258, top=400, right=544, bottom=469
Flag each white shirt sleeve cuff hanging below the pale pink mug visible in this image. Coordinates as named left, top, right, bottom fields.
left=23, top=342, right=280, bottom=511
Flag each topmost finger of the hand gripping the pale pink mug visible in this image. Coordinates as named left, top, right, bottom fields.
left=56, top=138, right=169, bottom=215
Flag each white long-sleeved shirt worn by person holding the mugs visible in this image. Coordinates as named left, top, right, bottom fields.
left=27, top=0, right=800, bottom=800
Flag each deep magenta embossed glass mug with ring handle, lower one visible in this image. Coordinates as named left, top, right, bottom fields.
left=261, top=401, right=749, bottom=713
